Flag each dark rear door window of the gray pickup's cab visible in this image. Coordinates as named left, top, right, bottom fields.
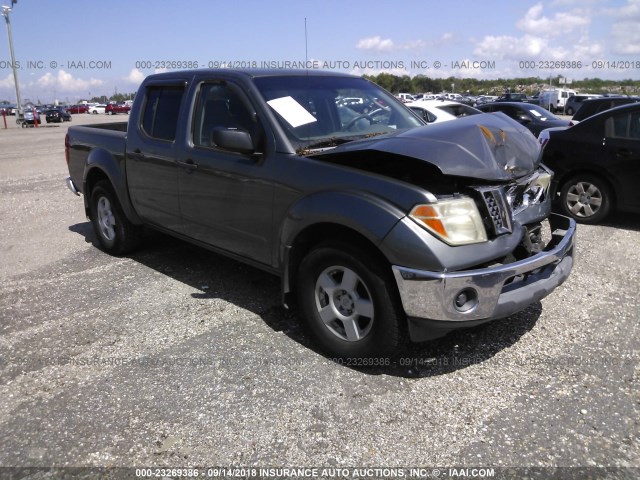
left=142, top=85, right=184, bottom=141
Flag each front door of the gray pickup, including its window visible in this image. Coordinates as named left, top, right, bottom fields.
left=178, top=81, right=274, bottom=264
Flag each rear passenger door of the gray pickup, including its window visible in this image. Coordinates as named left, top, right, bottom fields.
left=126, top=81, right=185, bottom=232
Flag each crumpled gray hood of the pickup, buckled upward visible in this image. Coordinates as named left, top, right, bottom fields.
left=312, top=113, right=540, bottom=180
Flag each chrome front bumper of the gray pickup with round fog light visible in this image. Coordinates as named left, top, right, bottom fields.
left=392, top=214, right=576, bottom=341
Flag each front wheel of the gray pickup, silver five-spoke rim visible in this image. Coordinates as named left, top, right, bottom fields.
left=297, top=243, right=406, bottom=359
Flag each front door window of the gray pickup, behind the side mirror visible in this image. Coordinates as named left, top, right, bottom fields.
left=193, top=83, right=256, bottom=147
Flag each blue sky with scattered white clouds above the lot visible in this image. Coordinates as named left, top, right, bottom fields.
left=0, top=0, right=640, bottom=103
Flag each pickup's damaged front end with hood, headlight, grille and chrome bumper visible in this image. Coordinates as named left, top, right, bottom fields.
left=308, top=114, right=576, bottom=341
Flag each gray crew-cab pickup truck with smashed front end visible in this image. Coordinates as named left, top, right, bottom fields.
left=66, top=70, right=575, bottom=358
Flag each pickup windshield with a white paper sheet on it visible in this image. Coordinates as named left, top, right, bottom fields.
left=255, top=75, right=423, bottom=149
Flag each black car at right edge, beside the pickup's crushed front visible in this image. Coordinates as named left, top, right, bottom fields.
left=542, top=103, right=640, bottom=223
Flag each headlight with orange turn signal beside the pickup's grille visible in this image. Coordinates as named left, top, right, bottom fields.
left=409, top=197, right=487, bottom=246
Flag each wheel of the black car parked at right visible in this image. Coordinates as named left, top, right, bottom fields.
left=560, top=174, right=613, bottom=224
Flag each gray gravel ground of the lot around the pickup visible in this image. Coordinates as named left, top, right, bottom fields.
left=0, top=115, right=640, bottom=478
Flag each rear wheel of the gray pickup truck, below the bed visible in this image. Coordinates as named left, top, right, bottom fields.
left=90, top=180, right=142, bottom=255
